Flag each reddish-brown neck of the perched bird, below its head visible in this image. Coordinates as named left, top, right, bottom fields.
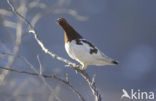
left=62, top=24, right=82, bottom=43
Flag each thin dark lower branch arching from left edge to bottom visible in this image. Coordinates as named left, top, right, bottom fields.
left=0, top=66, right=85, bottom=101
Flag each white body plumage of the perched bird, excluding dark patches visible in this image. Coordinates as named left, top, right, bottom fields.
left=65, top=40, right=115, bottom=69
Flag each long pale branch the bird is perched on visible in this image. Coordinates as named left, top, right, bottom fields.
left=7, top=0, right=101, bottom=101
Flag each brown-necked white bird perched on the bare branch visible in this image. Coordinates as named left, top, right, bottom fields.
left=57, top=17, right=118, bottom=70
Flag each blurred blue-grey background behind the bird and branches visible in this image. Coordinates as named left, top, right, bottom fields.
left=0, top=0, right=156, bottom=101
